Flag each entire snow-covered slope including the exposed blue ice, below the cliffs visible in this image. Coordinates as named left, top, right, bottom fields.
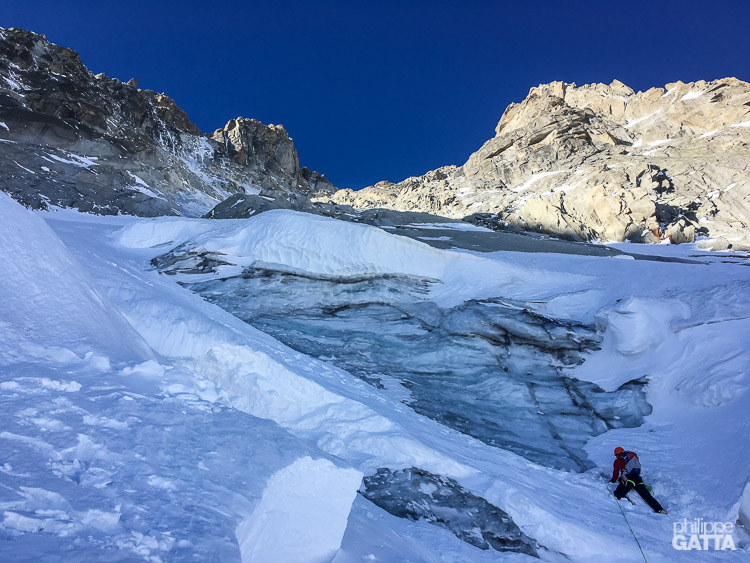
left=0, top=194, right=750, bottom=562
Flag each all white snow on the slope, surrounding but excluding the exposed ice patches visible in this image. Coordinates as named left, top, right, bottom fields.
left=0, top=197, right=750, bottom=562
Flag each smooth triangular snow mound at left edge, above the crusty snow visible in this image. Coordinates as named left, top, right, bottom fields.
left=0, top=192, right=151, bottom=360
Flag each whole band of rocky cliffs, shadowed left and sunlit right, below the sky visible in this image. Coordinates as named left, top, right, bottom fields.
left=0, top=24, right=750, bottom=249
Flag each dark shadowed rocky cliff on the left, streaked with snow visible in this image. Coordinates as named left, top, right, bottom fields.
left=0, top=29, right=335, bottom=216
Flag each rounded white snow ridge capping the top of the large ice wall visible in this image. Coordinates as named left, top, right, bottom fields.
left=118, top=210, right=585, bottom=305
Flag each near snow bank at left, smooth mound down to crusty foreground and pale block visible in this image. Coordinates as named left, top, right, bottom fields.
left=0, top=198, right=368, bottom=561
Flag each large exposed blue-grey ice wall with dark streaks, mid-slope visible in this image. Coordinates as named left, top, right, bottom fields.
left=165, top=262, right=651, bottom=471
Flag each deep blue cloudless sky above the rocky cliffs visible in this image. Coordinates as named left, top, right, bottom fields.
left=0, top=0, right=750, bottom=188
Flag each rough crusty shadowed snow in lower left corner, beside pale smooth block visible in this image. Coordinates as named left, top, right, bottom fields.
left=0, top=360, right=334, bottom=561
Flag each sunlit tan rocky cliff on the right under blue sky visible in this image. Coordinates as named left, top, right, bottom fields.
left=330, top=78, right=750, bottom=249
